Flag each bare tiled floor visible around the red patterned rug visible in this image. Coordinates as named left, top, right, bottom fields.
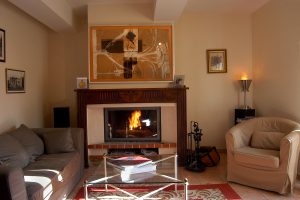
left=68, top=153, right=300, bottom=200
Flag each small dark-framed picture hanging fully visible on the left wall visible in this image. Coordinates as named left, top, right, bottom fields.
left=5, top=69, right=25, bottom=93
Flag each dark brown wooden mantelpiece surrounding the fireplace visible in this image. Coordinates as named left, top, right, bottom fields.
left=76, top=87, right=188, bottom=167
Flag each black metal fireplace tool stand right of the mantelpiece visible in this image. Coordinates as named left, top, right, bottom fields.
left=186, top=121, right=205, bottom=172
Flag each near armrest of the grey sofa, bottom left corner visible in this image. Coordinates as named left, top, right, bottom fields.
left=0, top=166, right=28, bottom=200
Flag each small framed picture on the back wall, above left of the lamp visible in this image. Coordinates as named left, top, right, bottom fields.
left=206, top=49, right=227, bottom=73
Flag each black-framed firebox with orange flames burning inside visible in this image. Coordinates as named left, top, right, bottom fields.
left=104, top=107, right=161, bottom=142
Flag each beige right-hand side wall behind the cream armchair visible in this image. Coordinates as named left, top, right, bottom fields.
left=253, top=0, right=300, bottom=122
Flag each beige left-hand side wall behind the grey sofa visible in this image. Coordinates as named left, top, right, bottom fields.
left=0, top=1, right=48, bottom=133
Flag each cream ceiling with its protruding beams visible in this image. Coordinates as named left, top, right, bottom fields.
left=8, top=0, right=270, bottom=32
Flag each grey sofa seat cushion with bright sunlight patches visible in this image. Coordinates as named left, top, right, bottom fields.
left=24, top=151, right=80, bottom=200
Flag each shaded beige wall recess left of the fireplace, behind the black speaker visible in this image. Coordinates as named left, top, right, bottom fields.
left=45, top=19, right=88, bottom=127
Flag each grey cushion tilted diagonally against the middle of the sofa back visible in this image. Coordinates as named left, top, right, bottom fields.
left=9, top=124, right=44, bottom=161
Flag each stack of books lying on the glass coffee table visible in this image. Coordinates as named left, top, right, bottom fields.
left=107, top=156, right=156, bottom=177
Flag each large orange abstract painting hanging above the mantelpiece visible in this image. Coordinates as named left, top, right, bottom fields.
left=89, top=25, right=173, bottom=83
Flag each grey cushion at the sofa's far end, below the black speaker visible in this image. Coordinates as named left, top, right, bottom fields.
left=43, top=128, right=75, bottom=154
